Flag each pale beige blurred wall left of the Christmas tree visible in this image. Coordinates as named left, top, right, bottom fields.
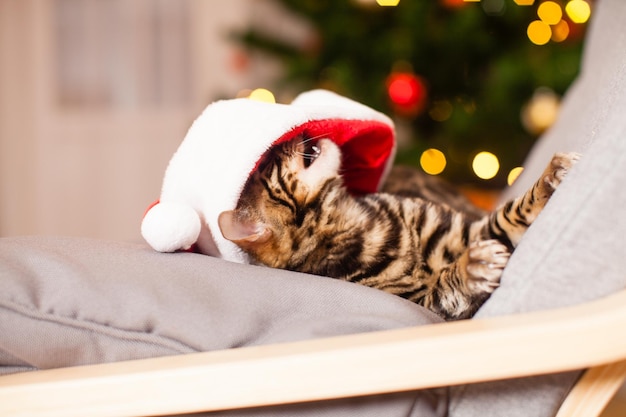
left=0, top=0, right=298, bottom=241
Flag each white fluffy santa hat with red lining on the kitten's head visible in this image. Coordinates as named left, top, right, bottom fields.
left=141, top=90, right=395, bottom=263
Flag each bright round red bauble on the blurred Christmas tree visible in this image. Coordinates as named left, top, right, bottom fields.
left=387, top=72, right=427, bottom=116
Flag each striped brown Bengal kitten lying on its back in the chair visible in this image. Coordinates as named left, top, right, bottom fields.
left=219, top=137, right=578, bottom=320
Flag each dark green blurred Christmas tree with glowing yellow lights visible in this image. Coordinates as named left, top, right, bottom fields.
left=233, top=0, right=590, bottom=187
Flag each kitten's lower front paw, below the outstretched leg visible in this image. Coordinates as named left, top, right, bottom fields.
left=466, top=239, right=511, bottom=294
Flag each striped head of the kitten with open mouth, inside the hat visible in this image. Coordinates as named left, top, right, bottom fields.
left=218, top=137, right=342, bottom=268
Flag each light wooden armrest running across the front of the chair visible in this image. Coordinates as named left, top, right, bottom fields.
left=0, top=290, right=626, bottom=417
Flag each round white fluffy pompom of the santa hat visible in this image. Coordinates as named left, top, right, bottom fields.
left=141, top=201, right=202, bottom=252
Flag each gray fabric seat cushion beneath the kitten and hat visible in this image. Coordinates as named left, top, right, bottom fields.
left=0, top=237, right=447, bottom=416
